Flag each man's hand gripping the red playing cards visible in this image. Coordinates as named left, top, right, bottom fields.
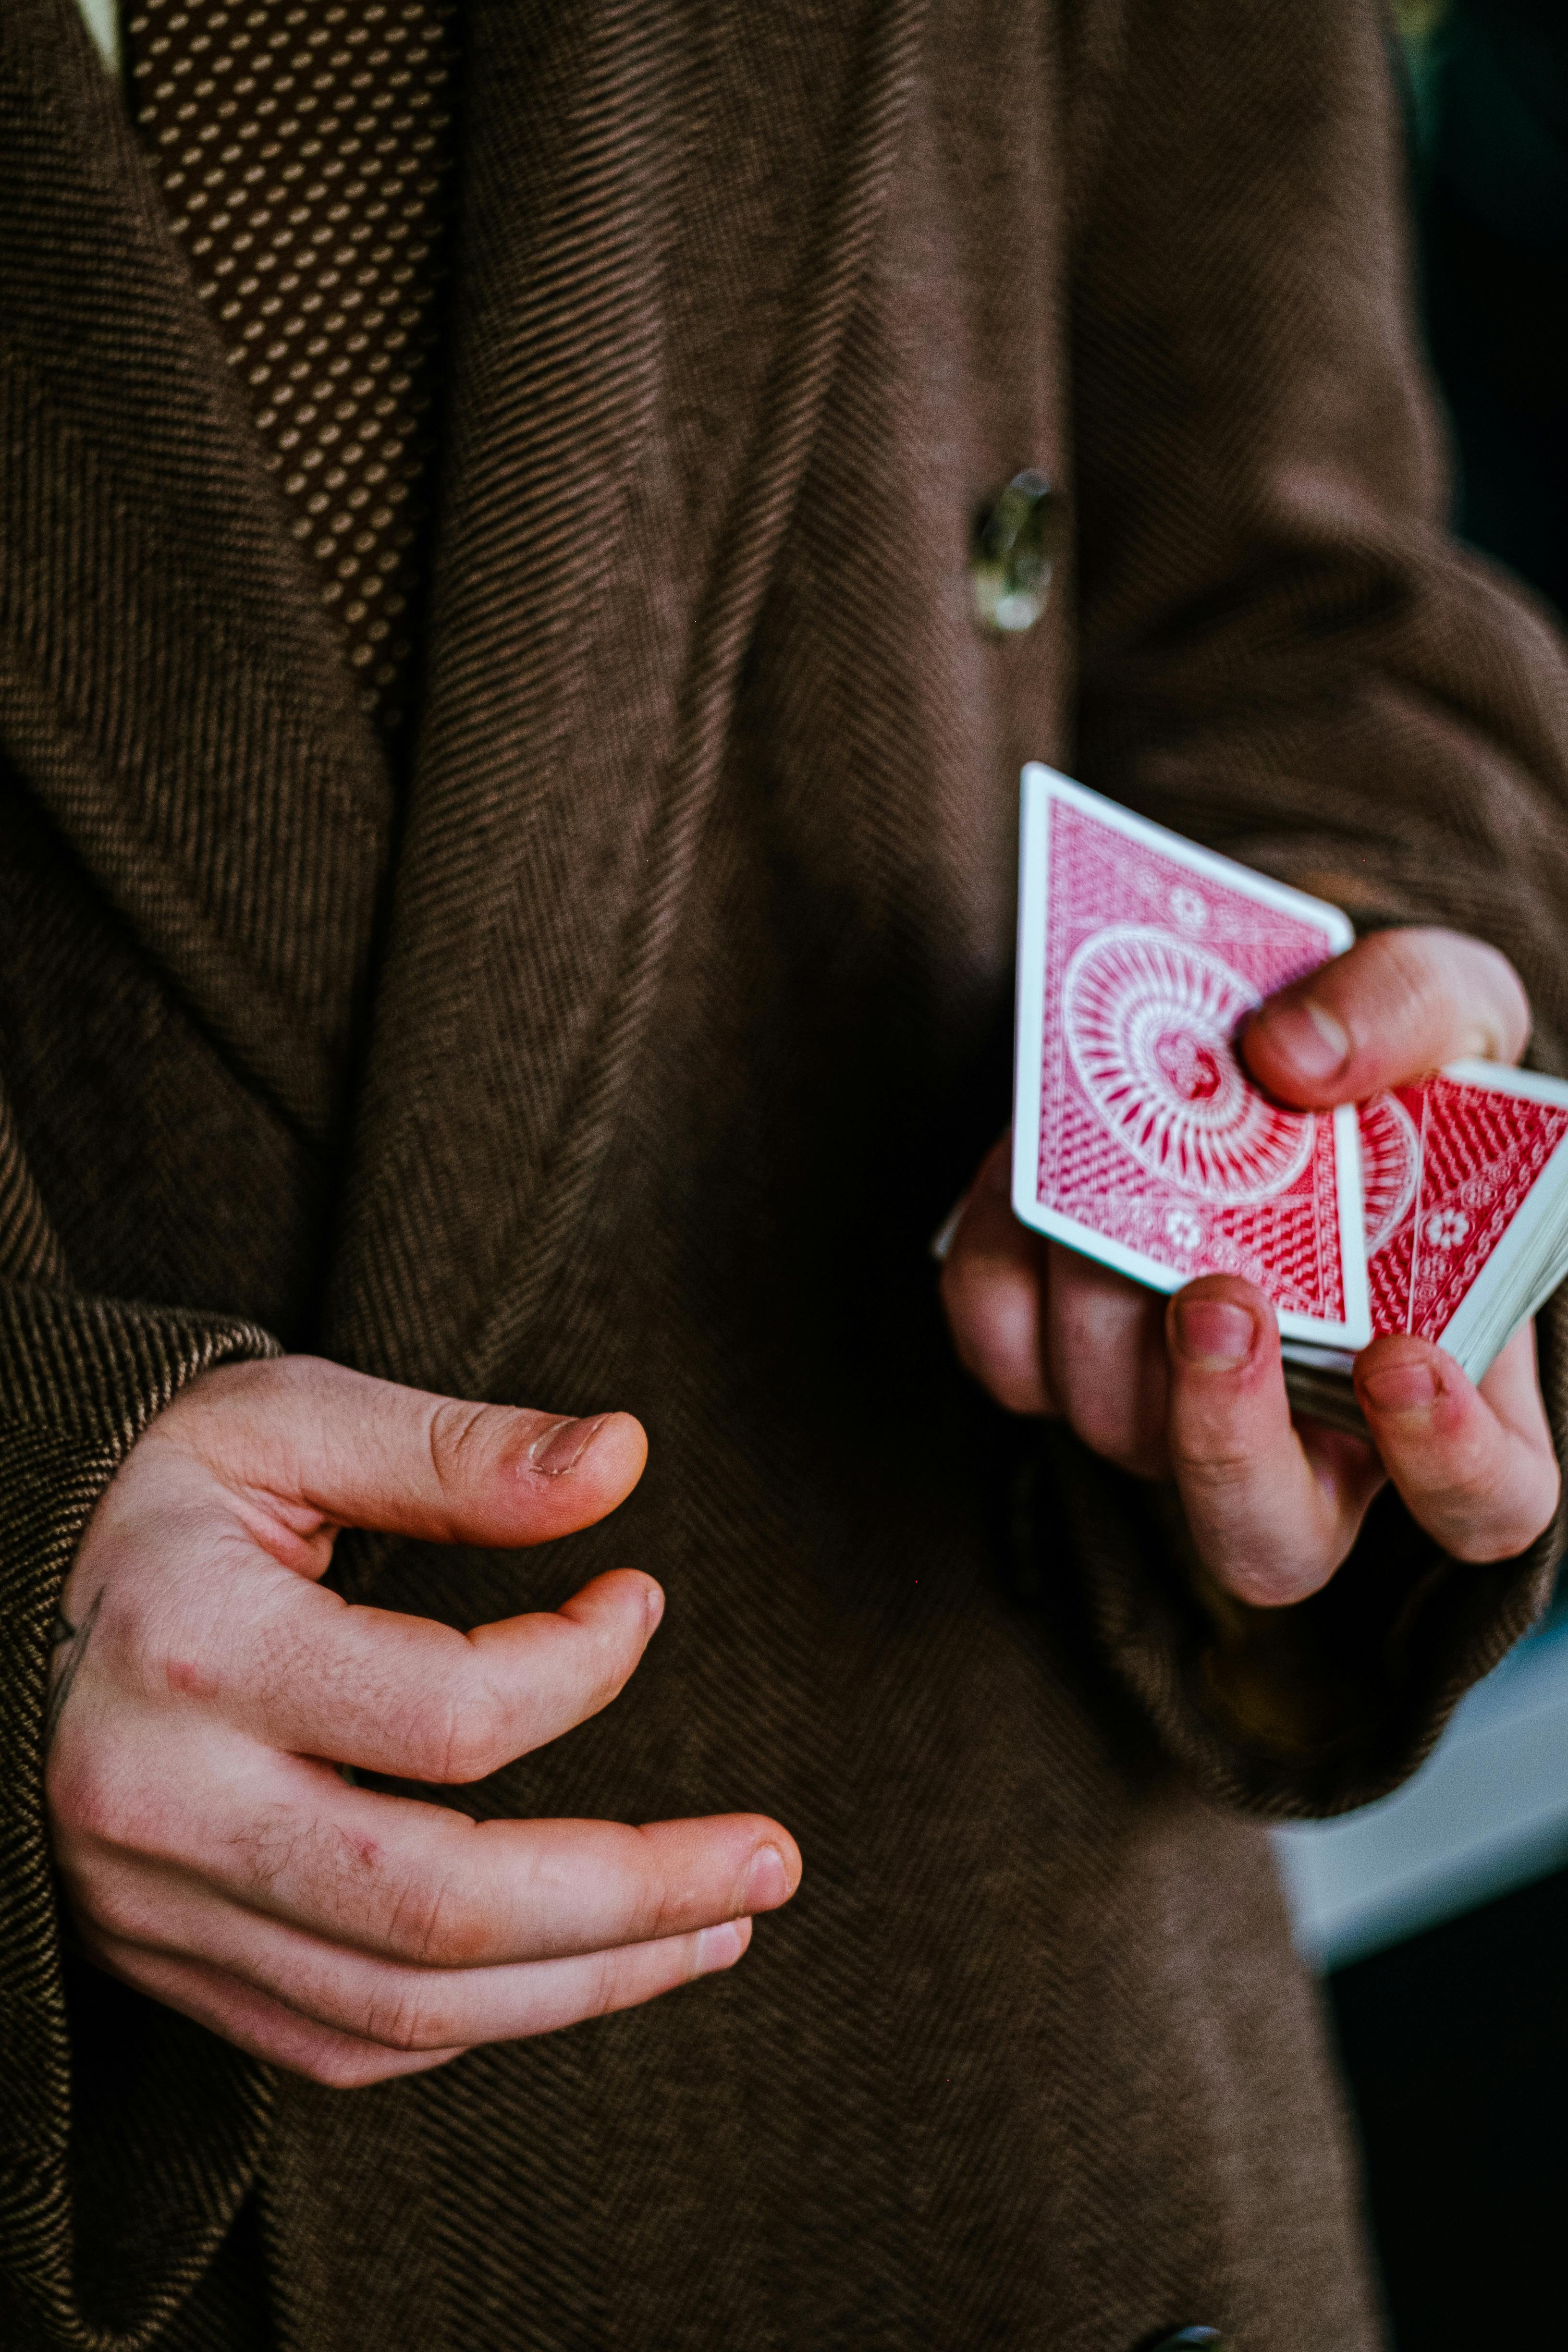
left=943, top=931, right=1558, bottom=1606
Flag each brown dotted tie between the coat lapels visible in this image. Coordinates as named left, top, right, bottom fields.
left=124, top=0, right=456, bottom=738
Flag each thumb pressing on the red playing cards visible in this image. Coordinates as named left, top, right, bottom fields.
left=1241, top=929, right=1531, bottom=1110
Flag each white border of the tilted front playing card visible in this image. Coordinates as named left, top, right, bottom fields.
left=1013, top=760, right=1373, bottom=1350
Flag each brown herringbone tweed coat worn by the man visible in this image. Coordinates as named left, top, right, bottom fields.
left=0, top=0, right=1568, bottom=2352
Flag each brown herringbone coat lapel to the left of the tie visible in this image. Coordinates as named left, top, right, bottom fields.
left=0, top=0, right=390, bottom=1139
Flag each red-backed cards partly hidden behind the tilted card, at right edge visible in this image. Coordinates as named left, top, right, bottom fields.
left=1361, top=1061, right=1568, bottom=1369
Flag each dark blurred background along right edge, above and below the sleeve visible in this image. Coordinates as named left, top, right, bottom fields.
left=1286, top=0, right=1568, bottom=2352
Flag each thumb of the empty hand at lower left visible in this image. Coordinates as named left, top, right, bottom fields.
left=139, top=1355, right=649, bottom=1545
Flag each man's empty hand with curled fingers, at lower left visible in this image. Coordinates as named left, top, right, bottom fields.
left=47, top=1357, right=799, bottom=2086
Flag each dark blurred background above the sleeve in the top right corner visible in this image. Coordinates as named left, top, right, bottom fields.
left=1396, top=0, right=1568, bottom=612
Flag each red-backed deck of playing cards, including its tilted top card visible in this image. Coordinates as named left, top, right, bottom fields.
left=1013, top=767, right=1568, bottom=1425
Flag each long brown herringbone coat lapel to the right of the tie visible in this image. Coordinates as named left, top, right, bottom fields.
left=331, top=0, right=921, bottom=1392
